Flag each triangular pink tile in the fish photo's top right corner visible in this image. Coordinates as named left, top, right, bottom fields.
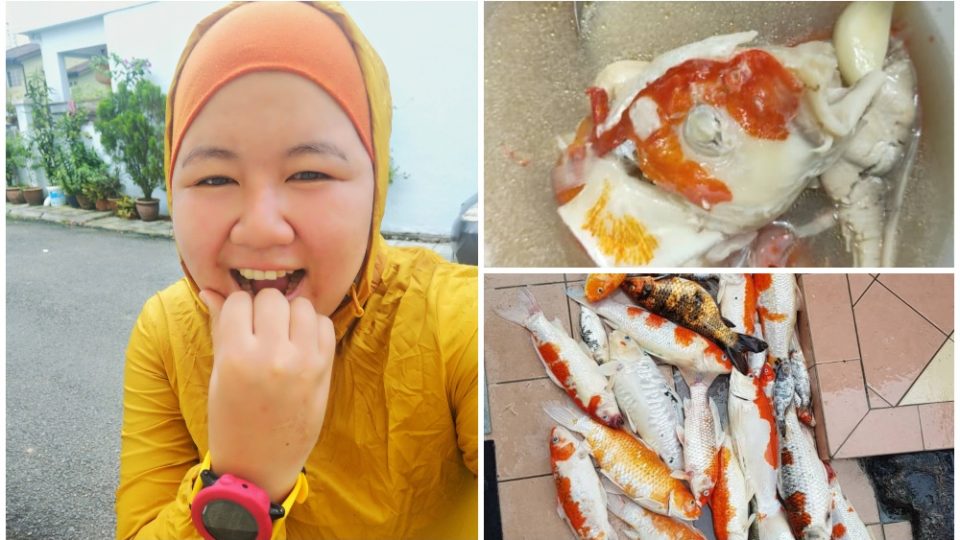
left=877, top=274, right=953, bottom=334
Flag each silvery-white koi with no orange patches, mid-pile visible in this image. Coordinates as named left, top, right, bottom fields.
left=610, top=330, right=683, bottom=471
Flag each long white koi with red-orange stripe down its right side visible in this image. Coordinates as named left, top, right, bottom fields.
left=727, top=364, right=782, bottom=516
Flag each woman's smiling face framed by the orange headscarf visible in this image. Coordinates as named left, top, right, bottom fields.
left=172, top=72, right=374, bottom=315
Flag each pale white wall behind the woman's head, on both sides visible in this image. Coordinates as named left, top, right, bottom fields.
left=103, top=2, right=478, bottom=235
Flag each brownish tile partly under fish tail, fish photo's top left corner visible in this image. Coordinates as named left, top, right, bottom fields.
left=483, top=284, right=570, bottom=383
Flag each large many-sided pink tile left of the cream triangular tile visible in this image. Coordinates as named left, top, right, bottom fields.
left=854, top=287, right=944, bottom=404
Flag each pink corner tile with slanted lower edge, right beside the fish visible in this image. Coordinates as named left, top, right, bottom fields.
left=816, top=361, right=869, bottom=455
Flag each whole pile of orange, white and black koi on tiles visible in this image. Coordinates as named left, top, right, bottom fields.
left=497, top=274, right=870, bottom=540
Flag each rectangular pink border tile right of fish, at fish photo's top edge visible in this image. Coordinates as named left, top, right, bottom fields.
left=801, top=274, right=860, bottom=364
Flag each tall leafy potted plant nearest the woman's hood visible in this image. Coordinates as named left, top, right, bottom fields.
left=95, top=54, right=166, bottom=221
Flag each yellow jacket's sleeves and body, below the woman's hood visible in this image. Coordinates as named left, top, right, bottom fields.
left=117, top=246, right=478, bottom=539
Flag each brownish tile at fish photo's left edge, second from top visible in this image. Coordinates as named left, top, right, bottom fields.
left=490, top=379, right=576, bottom=480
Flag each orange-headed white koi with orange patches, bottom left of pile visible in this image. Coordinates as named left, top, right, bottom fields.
left=550, top=426, right=617, bottom=540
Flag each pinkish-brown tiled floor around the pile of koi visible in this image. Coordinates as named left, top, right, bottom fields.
left=484, top=274, right=932, bottom=540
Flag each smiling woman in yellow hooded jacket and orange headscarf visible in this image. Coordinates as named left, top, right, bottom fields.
left=117, top=3, right=478, bottom=539
